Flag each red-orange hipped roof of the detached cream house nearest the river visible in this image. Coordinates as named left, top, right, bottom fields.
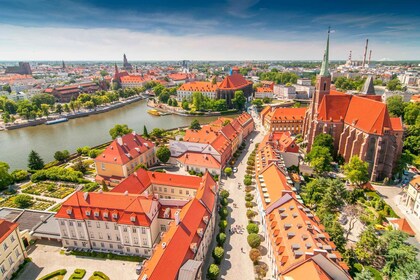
left=95, top=132, right=155, bottom=164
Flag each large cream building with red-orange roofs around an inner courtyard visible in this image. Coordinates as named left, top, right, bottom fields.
left=55, top=169, right=217, bottom=280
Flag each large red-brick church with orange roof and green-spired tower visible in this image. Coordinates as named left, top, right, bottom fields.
left=303, top=31, right=403, bottom=181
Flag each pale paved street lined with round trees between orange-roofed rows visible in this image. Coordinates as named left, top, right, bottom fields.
left=220, top=111, right=263, bottom=280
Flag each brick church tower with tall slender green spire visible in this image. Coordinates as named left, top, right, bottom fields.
left=311, top=28, right=331, bottom=119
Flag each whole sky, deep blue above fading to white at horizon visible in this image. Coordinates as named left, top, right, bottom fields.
left=0, top=0, right=420, bottom=61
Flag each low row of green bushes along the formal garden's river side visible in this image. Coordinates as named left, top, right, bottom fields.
left=31, top=166, right=84, bottom=183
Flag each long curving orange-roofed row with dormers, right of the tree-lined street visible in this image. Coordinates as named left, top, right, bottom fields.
left=255, top=135, right=351, bottom=279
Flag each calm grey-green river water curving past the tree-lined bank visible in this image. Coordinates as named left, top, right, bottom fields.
left=0, top=100, right=221, bottom=170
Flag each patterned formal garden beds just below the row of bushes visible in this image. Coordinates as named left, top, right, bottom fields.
left=22, top=181, right=75, bottom=199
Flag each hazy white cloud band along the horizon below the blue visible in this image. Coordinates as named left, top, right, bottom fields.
left=0, top=24, right=420, bottom=61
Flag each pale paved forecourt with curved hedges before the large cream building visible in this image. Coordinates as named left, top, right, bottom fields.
left=17, top=241, right=138, bottom=280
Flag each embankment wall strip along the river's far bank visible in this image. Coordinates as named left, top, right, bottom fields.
left=0, top=96, right=146, bottom=131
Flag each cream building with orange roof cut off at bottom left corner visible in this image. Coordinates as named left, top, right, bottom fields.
left=0, top=219, right=26, bottom=280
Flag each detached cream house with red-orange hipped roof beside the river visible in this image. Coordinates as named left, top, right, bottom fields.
left=95, top=132, right=156, bottom=185
